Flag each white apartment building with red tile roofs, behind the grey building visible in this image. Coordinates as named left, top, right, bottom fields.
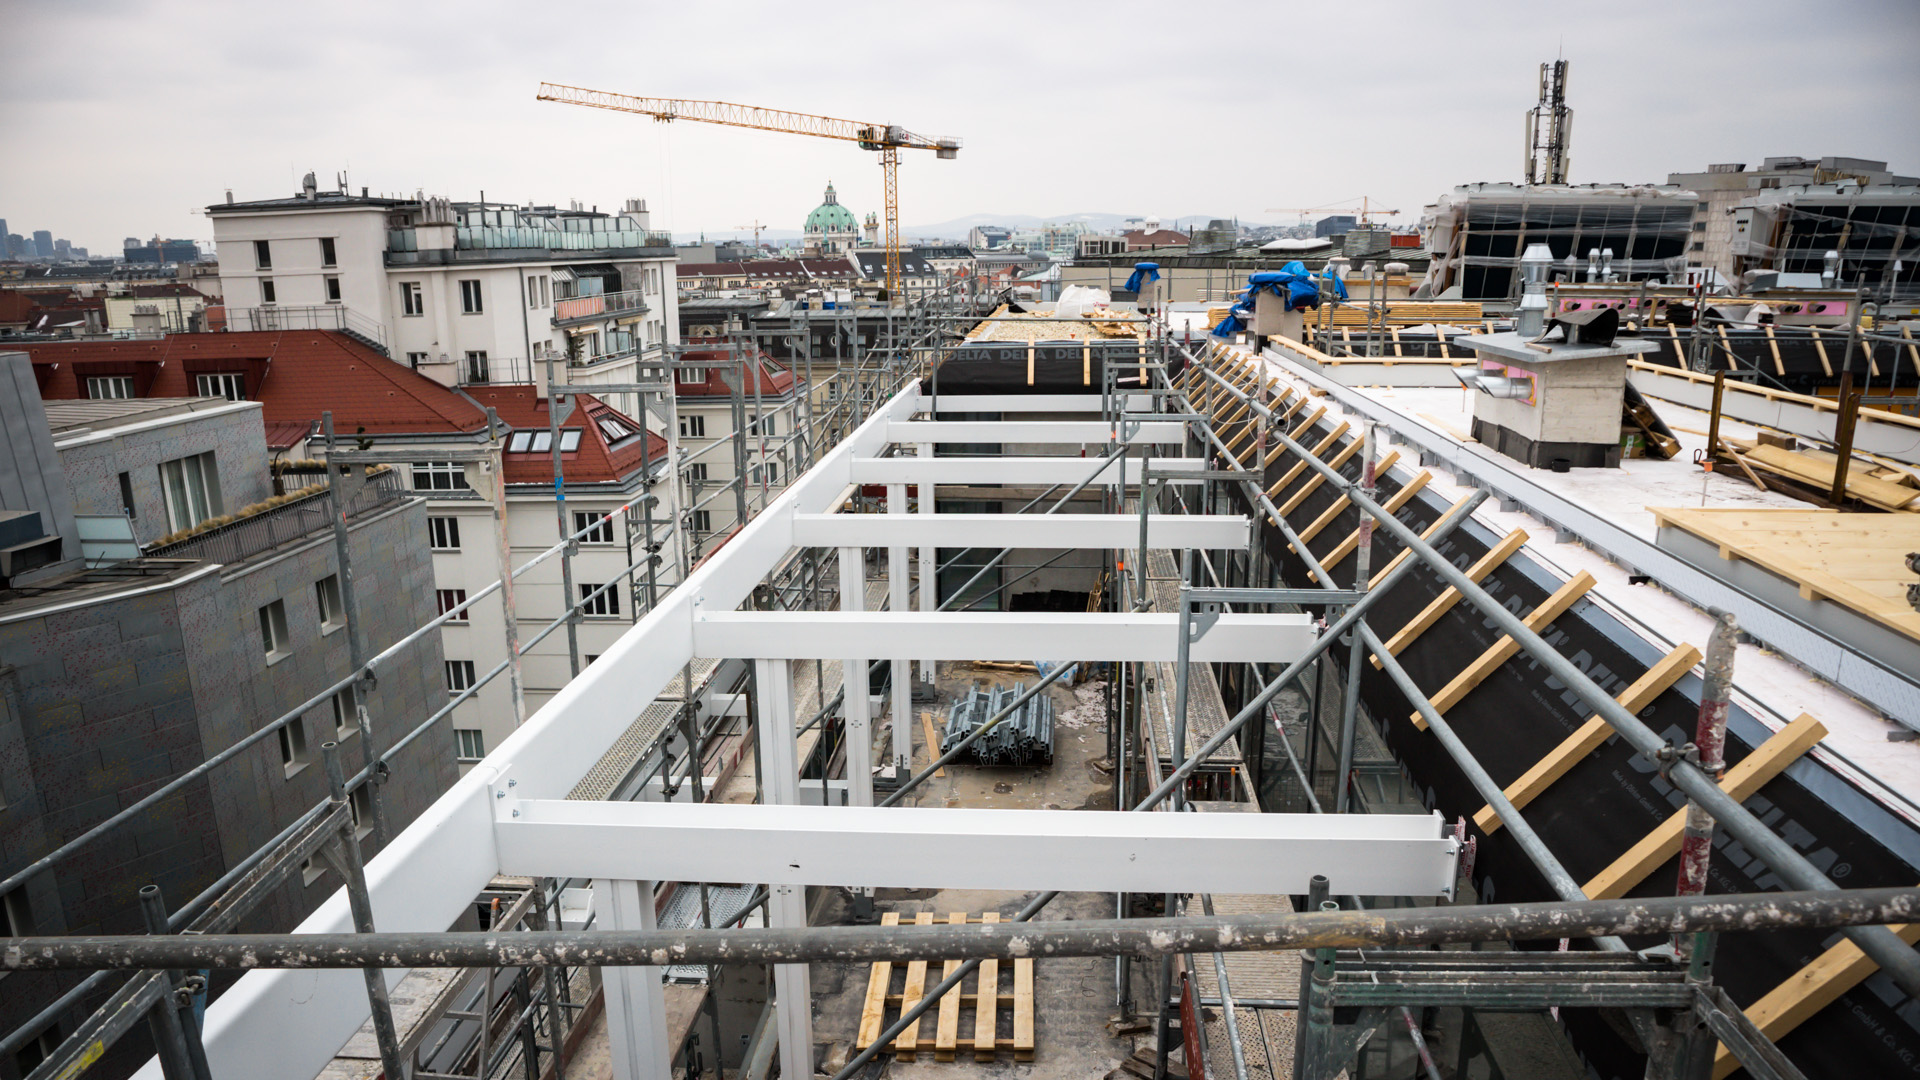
left=20, top=331, right=682, bottom=767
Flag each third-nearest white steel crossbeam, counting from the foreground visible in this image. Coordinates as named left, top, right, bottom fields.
left=793, top=513, right=1254, bottom=552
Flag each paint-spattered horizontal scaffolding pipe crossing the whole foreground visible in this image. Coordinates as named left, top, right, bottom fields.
left=0, top=886, right=1920, bottom=972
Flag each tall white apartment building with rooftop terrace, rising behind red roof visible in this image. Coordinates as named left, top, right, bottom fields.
left=207, top=173, right=680, bottom=413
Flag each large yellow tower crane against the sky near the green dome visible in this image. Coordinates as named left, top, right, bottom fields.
left=538, top=83, right=960, bottom=304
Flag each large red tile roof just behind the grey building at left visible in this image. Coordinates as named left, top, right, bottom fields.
left=21, top=331, right=486, bottom=434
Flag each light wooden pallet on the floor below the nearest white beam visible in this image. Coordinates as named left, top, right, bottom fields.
left=854, top=911, right=1033, bottom=1061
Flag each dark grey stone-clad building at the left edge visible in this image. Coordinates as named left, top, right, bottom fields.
left=0, top=354, right=457, bottom=1076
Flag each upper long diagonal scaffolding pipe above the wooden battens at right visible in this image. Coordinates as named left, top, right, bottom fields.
left=1202, top=353, right=1920, bottom=997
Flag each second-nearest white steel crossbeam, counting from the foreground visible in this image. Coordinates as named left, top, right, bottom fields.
left=693, top=611, right=1315, bottom=661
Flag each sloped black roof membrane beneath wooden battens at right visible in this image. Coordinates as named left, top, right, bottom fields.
left=1221, top=405, right=1920, bottom=1080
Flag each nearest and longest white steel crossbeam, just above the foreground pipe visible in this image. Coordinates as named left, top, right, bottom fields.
left=495, top=799, right=1457, bottom=896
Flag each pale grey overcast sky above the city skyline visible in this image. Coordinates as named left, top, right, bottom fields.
left=0, top=0, right=1920, bottom=252
